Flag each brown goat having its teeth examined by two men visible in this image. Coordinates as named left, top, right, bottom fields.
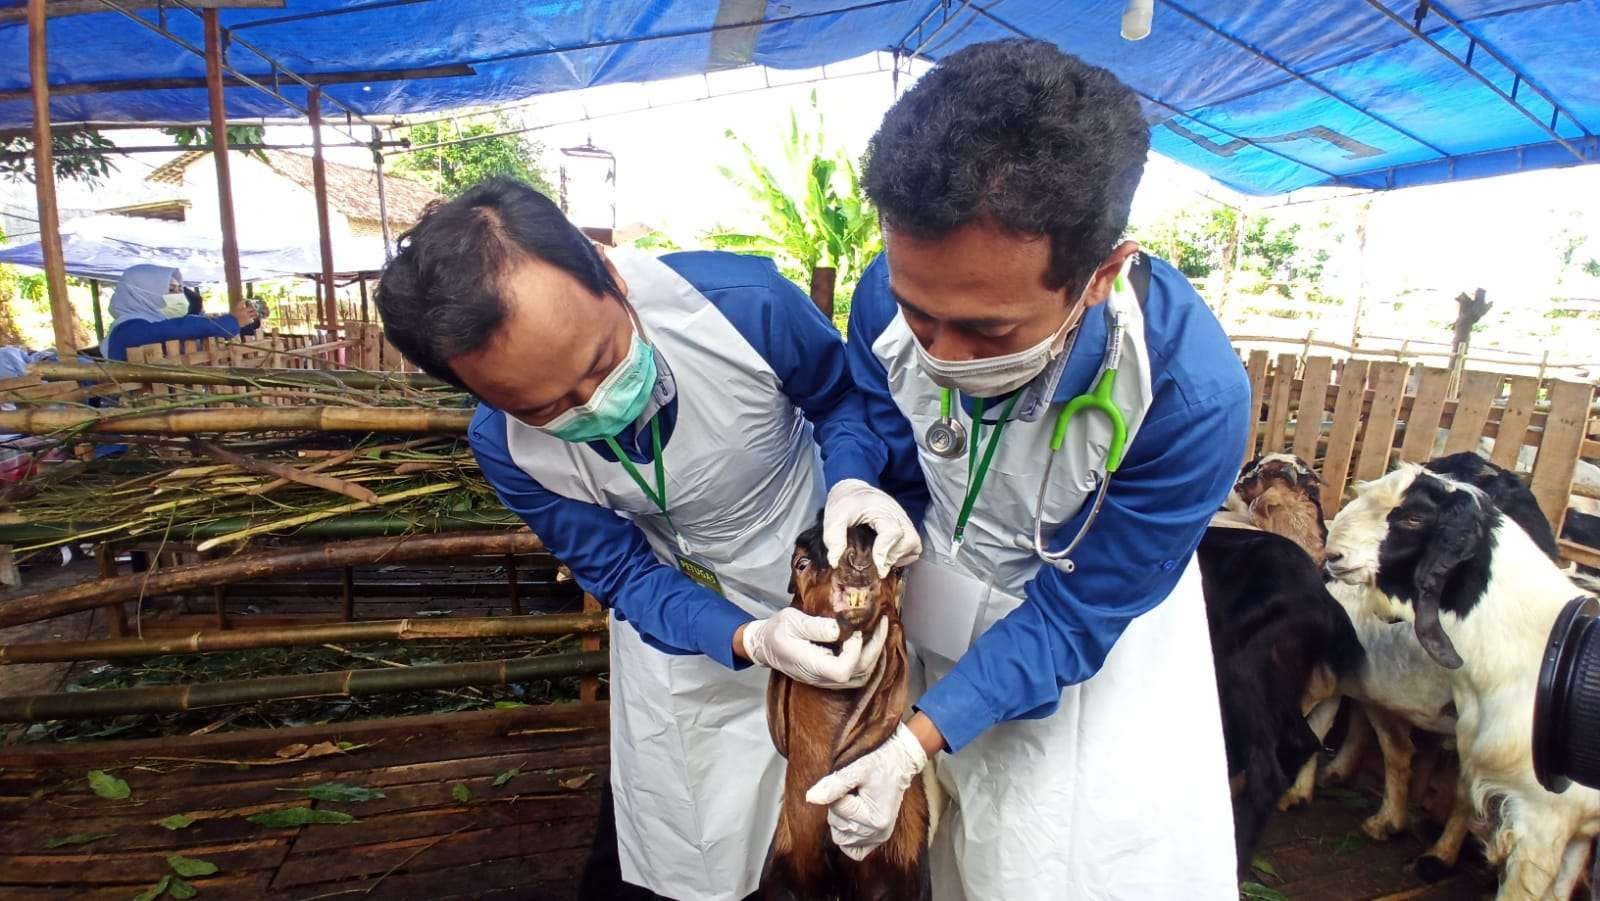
left=762, top=527, right=931, bottom=901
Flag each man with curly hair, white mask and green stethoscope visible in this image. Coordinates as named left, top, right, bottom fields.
left=810, top=40, right=1250, bottom=901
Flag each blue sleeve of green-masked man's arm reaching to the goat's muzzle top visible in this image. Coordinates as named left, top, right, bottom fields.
left=661, top=251, right=885, bottom=488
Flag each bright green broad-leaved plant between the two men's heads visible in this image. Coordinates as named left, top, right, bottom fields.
left=706, top=91, right=883, bottom=298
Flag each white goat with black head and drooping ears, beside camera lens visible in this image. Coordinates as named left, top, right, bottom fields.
left=1328, top=464, right=1600, bottom=901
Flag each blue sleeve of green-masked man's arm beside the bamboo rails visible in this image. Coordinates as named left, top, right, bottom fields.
left=467, top=405, right=752, bottom=667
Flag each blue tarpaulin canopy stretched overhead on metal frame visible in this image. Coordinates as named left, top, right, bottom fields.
left=0, top=0, right=1600, bottom=194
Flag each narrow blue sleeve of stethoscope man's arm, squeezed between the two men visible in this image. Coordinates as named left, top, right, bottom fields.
left=845, top=254, right=928, bottom=522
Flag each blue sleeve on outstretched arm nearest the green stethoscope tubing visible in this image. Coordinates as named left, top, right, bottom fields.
left=917, top=371, right=1250, bottom=752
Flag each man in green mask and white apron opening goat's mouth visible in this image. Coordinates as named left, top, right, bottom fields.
left=378, top=178, right=920, bottom=901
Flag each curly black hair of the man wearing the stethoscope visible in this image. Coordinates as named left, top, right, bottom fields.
left=864, top=40, right=1150, bottom=293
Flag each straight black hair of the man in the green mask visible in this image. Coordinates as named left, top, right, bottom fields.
left=374, top=176, right=622, bottom=390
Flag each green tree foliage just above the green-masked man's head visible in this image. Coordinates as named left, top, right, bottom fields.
left=394, top=115, right=555, bottom=197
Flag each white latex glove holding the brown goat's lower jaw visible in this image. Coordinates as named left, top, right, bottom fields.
left=744, top=607, right=890, bottom=688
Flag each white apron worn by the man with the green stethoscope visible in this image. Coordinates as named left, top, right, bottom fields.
left=872, top=273, right=1238, bottom=901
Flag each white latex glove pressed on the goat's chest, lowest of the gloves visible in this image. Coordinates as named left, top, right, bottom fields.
left=805, top=723, right=928, bottom=861
